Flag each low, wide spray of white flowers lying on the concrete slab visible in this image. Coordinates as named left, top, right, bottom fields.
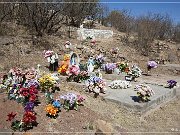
left=109, top=80, right=131, bottom=89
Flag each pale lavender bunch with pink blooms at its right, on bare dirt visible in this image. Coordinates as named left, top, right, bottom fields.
left=60, top=93, right=85, bottom=111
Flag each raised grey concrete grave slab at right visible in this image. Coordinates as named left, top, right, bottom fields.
left=104, top=82, right=176, bottom=114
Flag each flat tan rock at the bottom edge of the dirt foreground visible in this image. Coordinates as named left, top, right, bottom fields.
left=95, top=120, right=114, bottom=135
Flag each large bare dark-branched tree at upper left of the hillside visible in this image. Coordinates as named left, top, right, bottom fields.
left=13, top=0, right=64, bottom=36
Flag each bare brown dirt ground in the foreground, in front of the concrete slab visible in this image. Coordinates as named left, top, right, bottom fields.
left=0, top=75, right=180, bottom=135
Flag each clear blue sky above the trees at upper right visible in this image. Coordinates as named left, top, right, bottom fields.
left=100, top=0, right=180, bottom=23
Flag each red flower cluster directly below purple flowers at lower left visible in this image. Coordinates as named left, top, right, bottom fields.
left=22, top=112, right=36, bottom=124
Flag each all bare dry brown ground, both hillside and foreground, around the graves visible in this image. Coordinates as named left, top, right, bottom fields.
left=0, top=23, right=180, bottom=135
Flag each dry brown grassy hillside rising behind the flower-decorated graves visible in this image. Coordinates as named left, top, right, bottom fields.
left=0, top=24, right=180, bottom=74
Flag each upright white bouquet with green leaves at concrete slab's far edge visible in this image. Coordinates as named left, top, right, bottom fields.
left=126, top=64, right=142, bottom=81
